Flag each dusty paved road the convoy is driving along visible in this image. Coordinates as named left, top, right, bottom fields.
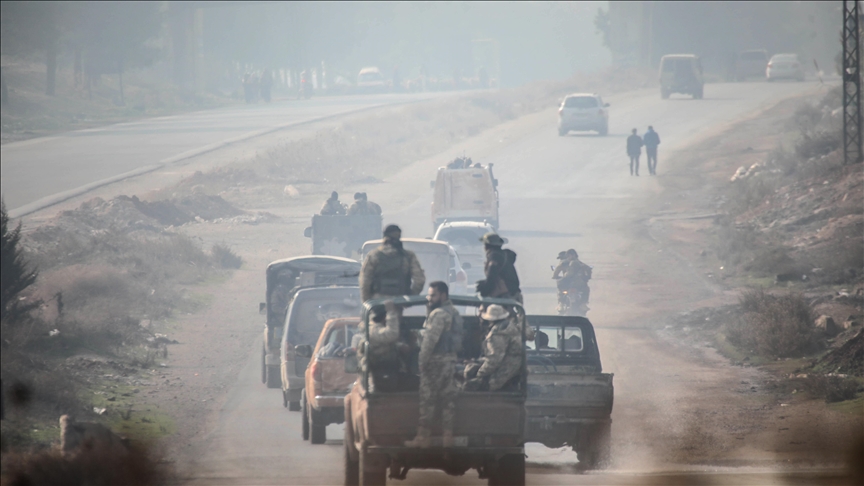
left=179, top=78, right=840, bottom=484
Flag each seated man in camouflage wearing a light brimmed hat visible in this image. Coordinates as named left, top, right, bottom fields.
left=465, top=304, right=525, bottom=391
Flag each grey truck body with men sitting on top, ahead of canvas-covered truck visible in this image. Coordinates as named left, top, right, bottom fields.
left=303, top=214, right=382, bottom=260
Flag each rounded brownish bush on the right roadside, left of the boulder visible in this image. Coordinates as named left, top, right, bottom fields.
left=729, top=289, right=815, bottom=358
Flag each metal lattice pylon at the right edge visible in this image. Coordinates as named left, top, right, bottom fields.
left=842, top=0, right=862, bottom=164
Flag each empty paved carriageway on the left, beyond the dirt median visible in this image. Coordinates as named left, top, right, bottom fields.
left=0, top=93, right=441, bottom=217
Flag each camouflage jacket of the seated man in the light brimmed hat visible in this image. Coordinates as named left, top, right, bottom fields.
left=477, top=319, right=525, bottom=391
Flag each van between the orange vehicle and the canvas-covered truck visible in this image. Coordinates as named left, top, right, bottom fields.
left=279, top=287, right=362, bottom=412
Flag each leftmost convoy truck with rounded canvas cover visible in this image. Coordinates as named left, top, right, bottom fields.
left=258, top=256, right=360, bottom=392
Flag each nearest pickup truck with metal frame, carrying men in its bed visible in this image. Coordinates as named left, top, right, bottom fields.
left=344, top=295, right=527, bottom=486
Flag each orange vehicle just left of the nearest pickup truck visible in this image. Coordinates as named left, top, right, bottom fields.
left=297, top=317, right=360, bottom=444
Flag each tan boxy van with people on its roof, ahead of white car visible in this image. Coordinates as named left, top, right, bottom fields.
left=431, top=164, right=498, bottom=233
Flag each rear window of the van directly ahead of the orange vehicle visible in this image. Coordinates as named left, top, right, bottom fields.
left=288, top=295, right=360, bottom=346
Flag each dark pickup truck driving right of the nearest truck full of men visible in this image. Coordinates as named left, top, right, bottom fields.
left=525, top=316, right=614, bottom=469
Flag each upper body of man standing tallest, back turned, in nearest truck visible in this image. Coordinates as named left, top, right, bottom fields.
left=360, top=224, right=426, bottom=302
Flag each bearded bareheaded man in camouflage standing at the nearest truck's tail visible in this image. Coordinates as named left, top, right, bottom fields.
left=405, top=282, right=462, bottom=447
